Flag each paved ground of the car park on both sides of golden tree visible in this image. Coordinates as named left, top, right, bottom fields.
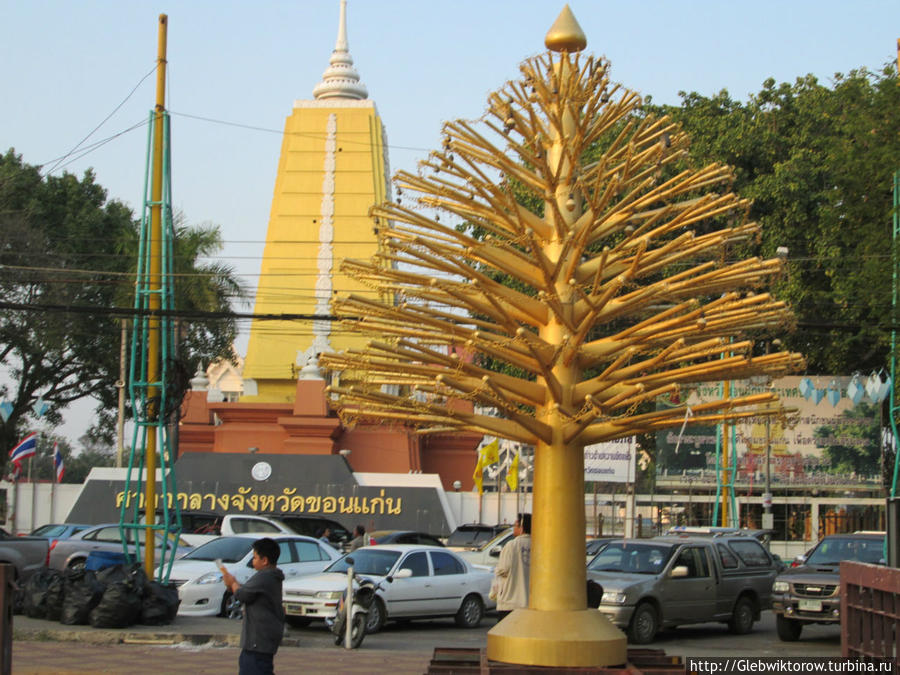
left=13, top=612, right=840, bottom=675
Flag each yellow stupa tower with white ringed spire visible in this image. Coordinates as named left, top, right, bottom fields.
left=241, top=0, right=389, bottom=403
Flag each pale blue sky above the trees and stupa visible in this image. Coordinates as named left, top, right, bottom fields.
left=0, top=0, right=900, bottom=436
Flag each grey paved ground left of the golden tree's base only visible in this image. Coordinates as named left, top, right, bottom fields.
left=13, top=615, right=486, bottom=675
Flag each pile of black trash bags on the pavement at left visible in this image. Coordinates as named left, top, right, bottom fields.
left=21, top=563, right=180, bottom=628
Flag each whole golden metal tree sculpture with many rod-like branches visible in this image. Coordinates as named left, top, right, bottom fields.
left=322, top=8, right=803, bottom=666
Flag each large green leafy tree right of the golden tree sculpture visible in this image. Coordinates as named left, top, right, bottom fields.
left=649, top=65, right=900, bottom=373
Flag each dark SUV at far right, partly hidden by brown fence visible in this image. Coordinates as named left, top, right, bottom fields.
left=772, top=532, right=885, bottom=642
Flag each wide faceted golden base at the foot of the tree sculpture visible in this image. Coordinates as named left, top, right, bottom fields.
left=487, top=609, right=627, bottom=666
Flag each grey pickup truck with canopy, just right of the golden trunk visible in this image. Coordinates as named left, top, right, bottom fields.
left=587, top=534, right=777, bottom=644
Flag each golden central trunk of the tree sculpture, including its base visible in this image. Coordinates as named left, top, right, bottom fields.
left=487, top=55, right=626, bottom=666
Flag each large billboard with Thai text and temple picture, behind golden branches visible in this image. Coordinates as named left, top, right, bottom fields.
left=656, top=376, right=885, bottom=485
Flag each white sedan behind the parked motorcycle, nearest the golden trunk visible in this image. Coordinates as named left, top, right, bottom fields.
left=283, top=544, right=495, bottom=633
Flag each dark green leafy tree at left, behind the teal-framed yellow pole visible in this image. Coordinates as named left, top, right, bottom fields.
left=0, top=150, right=243, bottom=468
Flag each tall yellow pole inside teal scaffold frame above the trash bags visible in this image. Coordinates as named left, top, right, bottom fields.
left=144, top=14, right=168, bottom=578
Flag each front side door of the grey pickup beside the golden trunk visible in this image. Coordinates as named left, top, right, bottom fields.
left=660, top=545, right=716, bottom=623
